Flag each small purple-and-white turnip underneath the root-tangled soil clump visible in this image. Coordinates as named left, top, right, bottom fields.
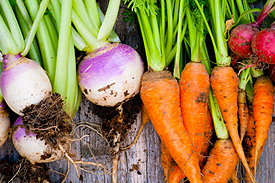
left=12, top=116, right=62, bottom=164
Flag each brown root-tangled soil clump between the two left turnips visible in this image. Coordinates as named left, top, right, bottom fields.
left=23, top=93, right=73, bottom=148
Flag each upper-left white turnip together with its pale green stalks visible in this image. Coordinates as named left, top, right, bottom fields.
left=0, top=0, right=52, bottom=115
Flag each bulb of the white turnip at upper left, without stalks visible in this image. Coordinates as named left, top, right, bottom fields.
left=1, top=54, right=52, bottom=116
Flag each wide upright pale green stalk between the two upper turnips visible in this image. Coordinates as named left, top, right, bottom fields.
left=53, top=0, right=72, bottom=97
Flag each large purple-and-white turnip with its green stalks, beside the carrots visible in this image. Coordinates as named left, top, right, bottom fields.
left=66, top=0, right=144, bottom=107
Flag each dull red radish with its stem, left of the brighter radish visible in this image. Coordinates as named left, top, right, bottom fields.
left=228, top=0, right=275, bottom=58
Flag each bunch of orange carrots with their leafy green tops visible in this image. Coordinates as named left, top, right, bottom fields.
left=126, top=0, right=274, bottom=183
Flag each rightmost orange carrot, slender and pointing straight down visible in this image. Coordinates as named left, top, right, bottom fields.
left=253, top=76, right=274, bottom=174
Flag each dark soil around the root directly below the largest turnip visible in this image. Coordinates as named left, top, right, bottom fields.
left=93, top=95, right=141, bottom=144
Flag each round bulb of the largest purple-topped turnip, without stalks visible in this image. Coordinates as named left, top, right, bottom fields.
left=78, top=43, right=144, bottom=106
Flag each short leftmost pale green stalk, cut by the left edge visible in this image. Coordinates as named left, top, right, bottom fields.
left=0, top=16, right=20, bottom=55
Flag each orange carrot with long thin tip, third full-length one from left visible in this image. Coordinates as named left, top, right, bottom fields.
left=210, top=67, right=254, bottom=180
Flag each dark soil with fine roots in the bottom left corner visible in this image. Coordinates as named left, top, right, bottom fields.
left=0, top=158, right=52, bottom=183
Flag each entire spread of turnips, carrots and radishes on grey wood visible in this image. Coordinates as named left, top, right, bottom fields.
left=0, top=0, right=275, bottom=183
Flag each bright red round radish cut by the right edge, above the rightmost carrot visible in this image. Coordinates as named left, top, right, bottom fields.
left=251, top=28, right=275, bottom=64
